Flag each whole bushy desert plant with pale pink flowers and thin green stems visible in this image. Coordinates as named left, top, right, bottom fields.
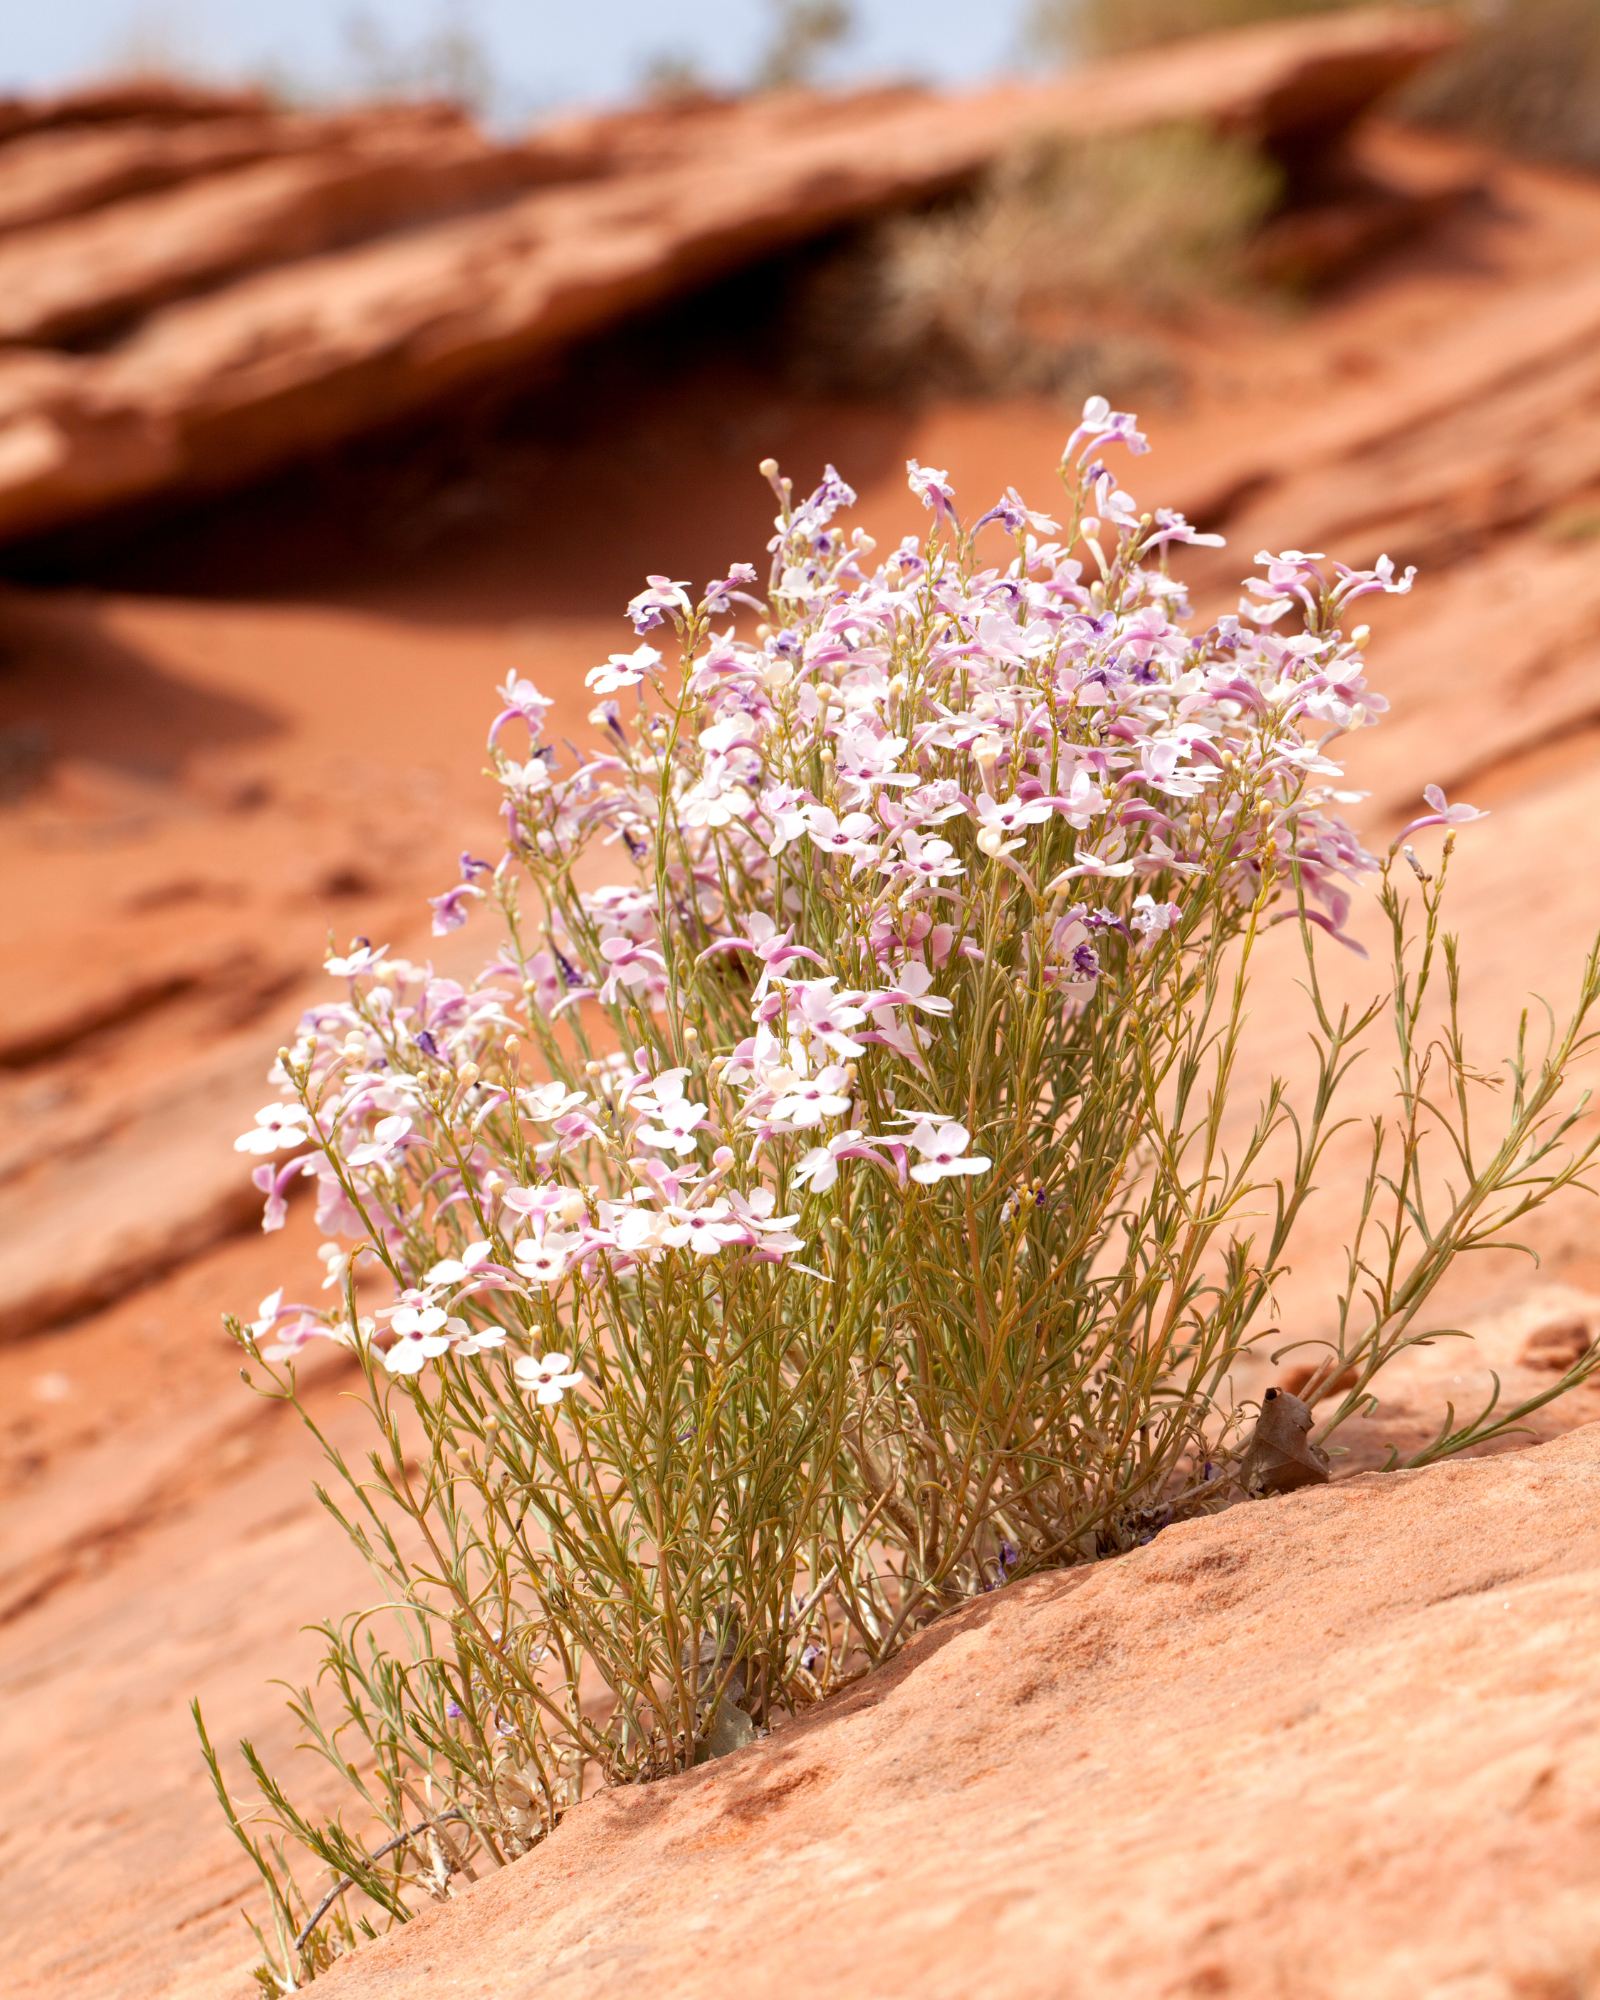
left=206, top=398, right=1600, bottom=1990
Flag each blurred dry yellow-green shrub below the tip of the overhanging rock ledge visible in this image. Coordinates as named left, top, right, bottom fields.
left=796, top=126, right=1278, bottom=400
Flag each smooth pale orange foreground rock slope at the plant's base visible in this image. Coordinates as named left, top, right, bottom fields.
left=310, top=1424, right=1600, bottom=2000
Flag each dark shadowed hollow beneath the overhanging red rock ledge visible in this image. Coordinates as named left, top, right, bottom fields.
left=0, top=260, right=916, bottom=624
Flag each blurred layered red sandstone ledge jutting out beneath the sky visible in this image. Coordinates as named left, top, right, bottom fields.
left=0, top=10, right=1450, bottom=556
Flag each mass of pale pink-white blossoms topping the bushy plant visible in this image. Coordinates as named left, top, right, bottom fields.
left=238, top=398, right=1416, bottom=1402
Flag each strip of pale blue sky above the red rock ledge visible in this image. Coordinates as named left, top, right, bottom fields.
left=0, top=0, right=1030, bottom=122
